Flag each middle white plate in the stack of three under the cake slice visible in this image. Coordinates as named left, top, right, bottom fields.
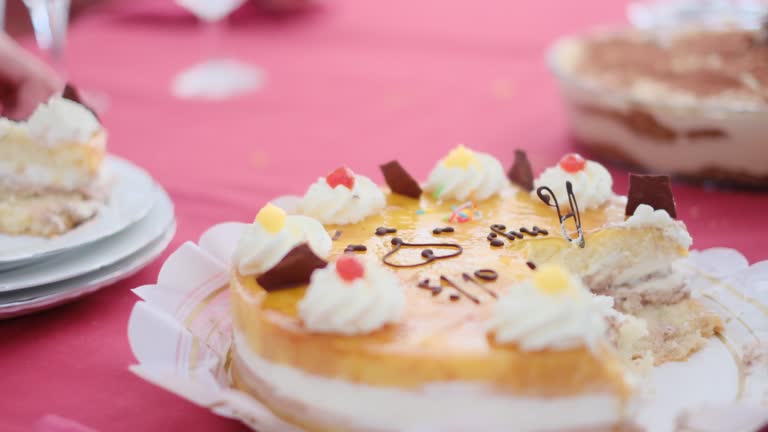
left=0, top=190, right=173, bottom=292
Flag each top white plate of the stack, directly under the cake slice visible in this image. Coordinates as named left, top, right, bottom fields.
left=0, top=156, right=158, bottom=271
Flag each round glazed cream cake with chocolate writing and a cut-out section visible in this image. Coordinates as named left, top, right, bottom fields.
left=230, top=147, right=721, bottom=431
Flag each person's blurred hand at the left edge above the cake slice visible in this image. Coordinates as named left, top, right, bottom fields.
left=0, top=33, right=64, bottom=120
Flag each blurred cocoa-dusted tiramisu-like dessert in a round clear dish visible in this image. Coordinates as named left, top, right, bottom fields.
left=550, top=25, right=768, bottom=186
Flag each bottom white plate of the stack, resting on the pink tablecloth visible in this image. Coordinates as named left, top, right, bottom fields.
left=0, top=222, right=176, bottom=319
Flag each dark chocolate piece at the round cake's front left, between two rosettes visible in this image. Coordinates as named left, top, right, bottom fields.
left=256, top=243, right=328, bottom=292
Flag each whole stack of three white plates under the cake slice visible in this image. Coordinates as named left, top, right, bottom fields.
left=0, top=156, right=176, bottom=318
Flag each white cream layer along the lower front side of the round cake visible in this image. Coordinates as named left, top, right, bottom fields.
left=234, top=331, right=621, bottom=432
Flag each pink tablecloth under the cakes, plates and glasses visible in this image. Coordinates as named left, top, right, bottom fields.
left=0, top=0, right=768, bottom=432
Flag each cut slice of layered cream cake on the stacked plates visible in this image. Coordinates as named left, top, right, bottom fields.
left=0, top=90, right=106, bottom=237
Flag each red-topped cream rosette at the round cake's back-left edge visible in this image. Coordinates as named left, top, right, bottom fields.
left=299, top=167, right=386, bottom=225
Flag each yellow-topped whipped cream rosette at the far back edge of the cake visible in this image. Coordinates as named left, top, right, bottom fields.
left=425, top=145, right=509, bottom=201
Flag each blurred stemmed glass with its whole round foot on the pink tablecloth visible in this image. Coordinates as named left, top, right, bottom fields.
left=171, top=0, right=264, bottom=99
